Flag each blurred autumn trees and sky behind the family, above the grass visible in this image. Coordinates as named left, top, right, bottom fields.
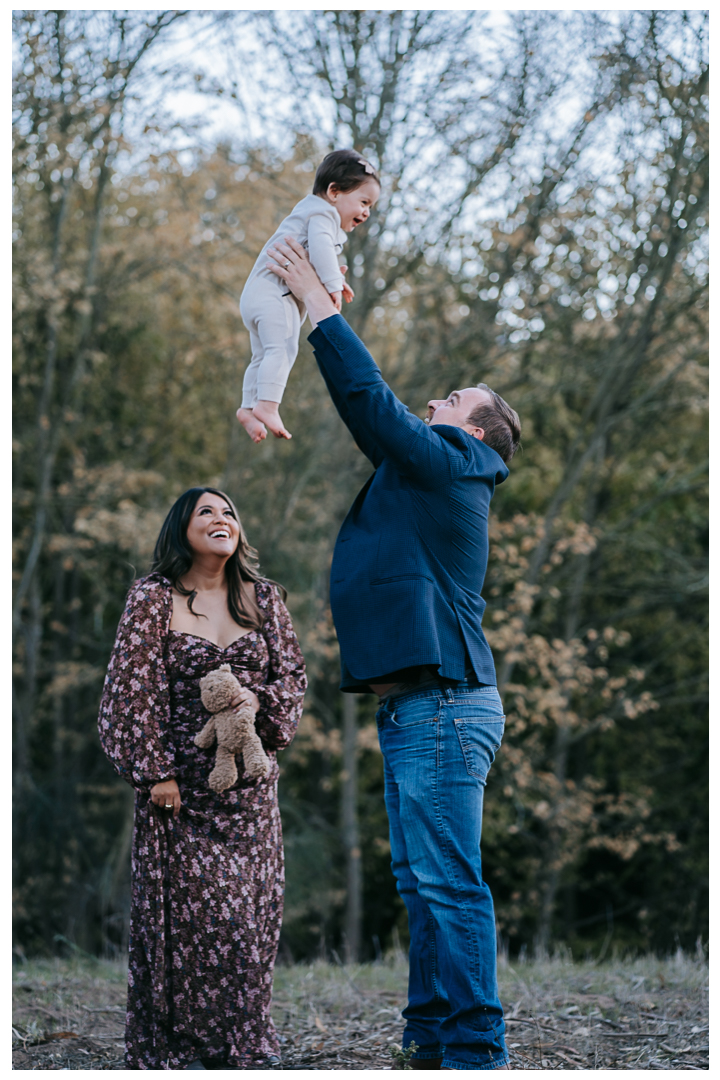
left=13, top=11, right=708, bottom=960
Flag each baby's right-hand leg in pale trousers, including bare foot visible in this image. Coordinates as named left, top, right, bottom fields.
left=253, top=296, right=300, bottom=438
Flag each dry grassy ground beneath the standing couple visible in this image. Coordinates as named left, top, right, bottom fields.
left=13, top=953, right=708, bottom=1071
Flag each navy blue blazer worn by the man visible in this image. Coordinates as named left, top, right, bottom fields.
left=309, top=314, right=507, bottom=692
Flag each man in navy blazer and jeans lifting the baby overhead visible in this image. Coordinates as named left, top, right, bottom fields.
left=271, top=241, right=520, bottom=1069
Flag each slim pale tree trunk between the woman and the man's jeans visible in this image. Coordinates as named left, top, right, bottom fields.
left=342, top=693, right=363, bottom=963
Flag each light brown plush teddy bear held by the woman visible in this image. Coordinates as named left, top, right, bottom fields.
left=194, top=664, right=270, bottom=794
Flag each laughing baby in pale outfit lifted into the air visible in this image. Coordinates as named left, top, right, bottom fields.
left=237, top=150, right=380, bottom=443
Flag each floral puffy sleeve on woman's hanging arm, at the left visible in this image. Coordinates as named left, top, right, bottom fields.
left=98, top=577, right=175, bottom=789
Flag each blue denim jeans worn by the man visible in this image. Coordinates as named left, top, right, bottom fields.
left=377, top=683, right=507, bottom=1069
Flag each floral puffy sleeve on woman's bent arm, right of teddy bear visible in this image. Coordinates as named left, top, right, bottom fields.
left=255, top=581, right=308, bottom=750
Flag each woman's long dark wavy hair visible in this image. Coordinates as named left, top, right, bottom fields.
left=151, top=487, right=287, bottom=630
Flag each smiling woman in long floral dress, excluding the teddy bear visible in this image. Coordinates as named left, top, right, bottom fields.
left=99, top=487, right=307, bottom=1069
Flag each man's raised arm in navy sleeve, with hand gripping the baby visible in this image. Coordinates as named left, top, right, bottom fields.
left=268, top=239, right=468, bottom=484
